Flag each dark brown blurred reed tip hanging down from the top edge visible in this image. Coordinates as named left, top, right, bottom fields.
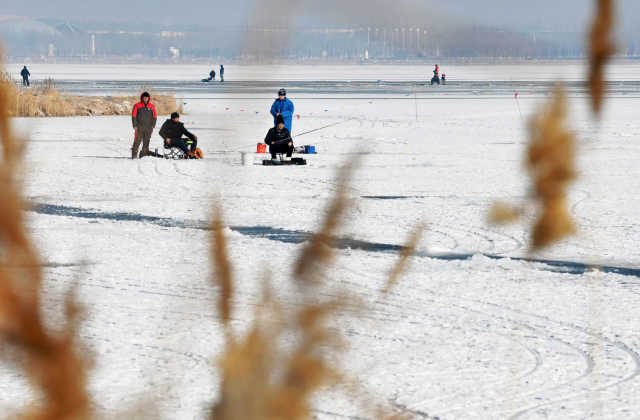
left=589, top=0, right=616, bottom=115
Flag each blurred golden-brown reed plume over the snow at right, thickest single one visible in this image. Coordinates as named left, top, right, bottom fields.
left=526, top=88, right=576, bottom=250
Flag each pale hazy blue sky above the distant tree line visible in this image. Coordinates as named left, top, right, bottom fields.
left=0, top=0, right=640, bottom=30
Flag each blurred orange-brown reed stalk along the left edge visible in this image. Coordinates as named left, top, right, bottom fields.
left=0, top=59, right=90, bottom=420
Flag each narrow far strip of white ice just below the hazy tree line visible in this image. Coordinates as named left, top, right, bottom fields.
left=6, top=60, right=640, bottom=82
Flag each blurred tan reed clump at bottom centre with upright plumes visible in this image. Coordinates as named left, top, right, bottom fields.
left=210, top=158, right=423, bottom=420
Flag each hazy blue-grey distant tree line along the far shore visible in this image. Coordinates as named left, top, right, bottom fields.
left=6, top=24, right=640, bottom=61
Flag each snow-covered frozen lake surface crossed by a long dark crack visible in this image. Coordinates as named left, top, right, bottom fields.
left=0, top=64, right=640, bottom=419
